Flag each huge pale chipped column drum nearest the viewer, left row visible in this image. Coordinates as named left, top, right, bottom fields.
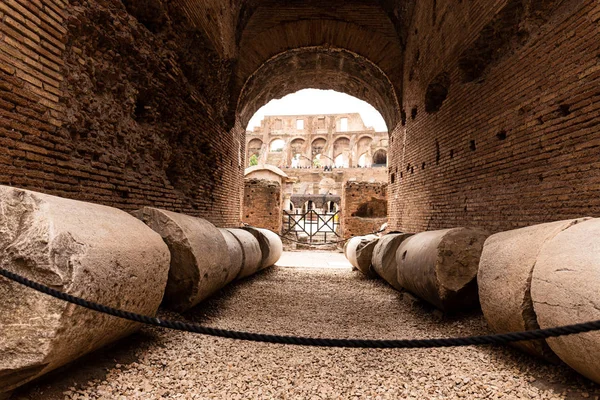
left=0, top=186, right=170, bottom=393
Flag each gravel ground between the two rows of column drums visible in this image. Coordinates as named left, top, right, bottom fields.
left=13, top=260, right=600, bottom=400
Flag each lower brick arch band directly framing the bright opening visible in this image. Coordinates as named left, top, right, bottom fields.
left=237, top=47, right=399, bottom=128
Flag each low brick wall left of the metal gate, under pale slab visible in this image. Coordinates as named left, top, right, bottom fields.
left=242, top=178, right=282, bottom=233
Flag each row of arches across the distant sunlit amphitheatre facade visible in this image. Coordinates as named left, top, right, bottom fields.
left=247, top=136, right=387, bottom=168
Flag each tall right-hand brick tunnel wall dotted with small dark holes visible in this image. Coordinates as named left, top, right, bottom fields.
left=389, top=0, right=600, bottom=231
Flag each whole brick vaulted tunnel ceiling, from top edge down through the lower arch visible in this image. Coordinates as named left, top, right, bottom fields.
left=232, top=0, right=408, bottom=129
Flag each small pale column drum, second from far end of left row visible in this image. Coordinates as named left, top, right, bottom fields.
left=220, top=228, right=262, bottom=279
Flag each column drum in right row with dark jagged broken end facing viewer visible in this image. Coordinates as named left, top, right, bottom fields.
left=396, top=228, right=488, bottom=312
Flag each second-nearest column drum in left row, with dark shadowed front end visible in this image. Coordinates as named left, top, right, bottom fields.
left=132, top=207, right=232, bottom=311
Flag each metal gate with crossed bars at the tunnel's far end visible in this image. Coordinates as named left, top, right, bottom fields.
left=282, top=210, right=341, bottom=243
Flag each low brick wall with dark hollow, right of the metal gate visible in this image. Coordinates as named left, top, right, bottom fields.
left=340, top=182, right=387, bottom=238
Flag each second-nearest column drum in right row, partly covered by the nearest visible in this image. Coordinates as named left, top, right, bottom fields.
left=477, top=219, right=583, bottom=361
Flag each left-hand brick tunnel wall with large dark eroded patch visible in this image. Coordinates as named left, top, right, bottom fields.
left=0, top=0, right=244, bottom=226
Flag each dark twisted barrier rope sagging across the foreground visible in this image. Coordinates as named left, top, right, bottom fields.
left=0, top=268, right=600, bottom=349
